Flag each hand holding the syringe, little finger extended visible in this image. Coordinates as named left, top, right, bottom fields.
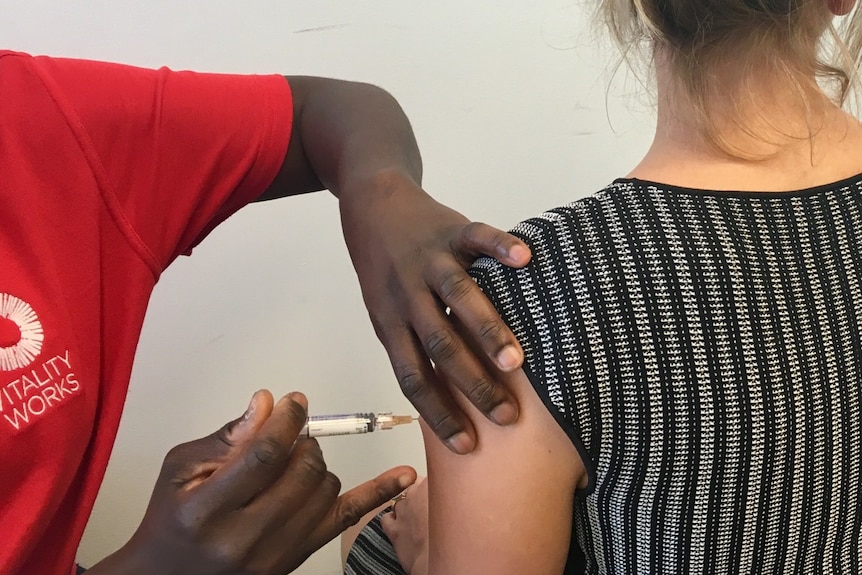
left=88, top=391, right=416, bottom=575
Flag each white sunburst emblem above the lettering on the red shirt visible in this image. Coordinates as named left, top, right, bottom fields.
left=0, top=293, right=45, bottom=371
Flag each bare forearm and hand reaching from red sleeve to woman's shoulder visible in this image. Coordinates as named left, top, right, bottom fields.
left=260, top=76, right=530, bottom=453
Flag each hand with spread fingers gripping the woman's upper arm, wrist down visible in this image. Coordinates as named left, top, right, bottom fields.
left=340, top=174, right=530, bottom=453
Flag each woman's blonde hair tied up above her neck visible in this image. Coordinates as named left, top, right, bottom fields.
left=599, top=0, right=862, bottom=144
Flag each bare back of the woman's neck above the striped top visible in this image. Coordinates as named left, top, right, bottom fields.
left=629, top=58, right=862, bottom=191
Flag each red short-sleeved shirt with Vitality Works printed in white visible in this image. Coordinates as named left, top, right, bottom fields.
left=0, top=52, right=293, bottom=575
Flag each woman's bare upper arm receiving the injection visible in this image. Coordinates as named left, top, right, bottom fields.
left=422, top=371, right=587, bottom=575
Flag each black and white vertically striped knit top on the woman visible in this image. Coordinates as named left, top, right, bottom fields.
left=473, top=176, right=862, bottom=574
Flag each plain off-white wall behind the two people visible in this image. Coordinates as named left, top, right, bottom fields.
left=0, top=0, right=652, bottom=575
